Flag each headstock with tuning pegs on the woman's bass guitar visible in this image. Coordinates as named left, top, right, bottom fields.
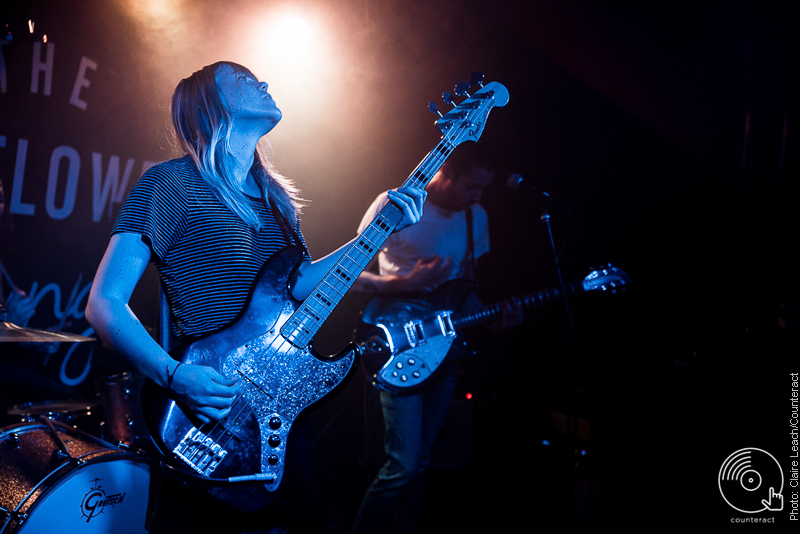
left=429, top=73, right=508, bottom=146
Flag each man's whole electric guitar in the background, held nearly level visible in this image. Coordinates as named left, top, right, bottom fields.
left=355, top=266, right=630, bottom=395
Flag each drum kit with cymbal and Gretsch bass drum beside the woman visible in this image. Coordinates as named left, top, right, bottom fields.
left=0, top=321, right=150, bottom=534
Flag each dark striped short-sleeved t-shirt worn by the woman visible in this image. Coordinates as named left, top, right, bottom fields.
left=112, top=156, right=302, bottom=340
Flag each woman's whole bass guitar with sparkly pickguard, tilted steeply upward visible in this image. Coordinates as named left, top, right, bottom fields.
left=145, top=77, right=508, bottom=510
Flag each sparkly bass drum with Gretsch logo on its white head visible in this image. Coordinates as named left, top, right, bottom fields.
left=0, top=420, right=150, bottom=534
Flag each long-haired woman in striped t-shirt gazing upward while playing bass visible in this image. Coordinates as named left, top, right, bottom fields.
left=86, top=62, right=425, bottom=533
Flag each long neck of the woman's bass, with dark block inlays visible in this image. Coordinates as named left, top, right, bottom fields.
left=281, top=136, right=455, bottom=348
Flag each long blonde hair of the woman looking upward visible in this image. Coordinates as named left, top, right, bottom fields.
left=172, top=61, right=303, bottom=230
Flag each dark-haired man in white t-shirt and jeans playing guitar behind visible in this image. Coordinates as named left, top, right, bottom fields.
left=353, top=142, right=521, bottom=534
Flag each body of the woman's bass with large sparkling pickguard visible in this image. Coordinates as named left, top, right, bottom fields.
left=144, top=248, right=359, bottom=511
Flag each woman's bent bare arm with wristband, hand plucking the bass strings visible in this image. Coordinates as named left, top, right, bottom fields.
left=86, top=233, right=238, bottom=423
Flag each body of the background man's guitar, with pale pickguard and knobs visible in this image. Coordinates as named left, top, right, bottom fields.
left=355, top=279, right=473, bottom=395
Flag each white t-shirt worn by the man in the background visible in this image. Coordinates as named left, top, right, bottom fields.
left=358, top=193, right=489, bottom=279
